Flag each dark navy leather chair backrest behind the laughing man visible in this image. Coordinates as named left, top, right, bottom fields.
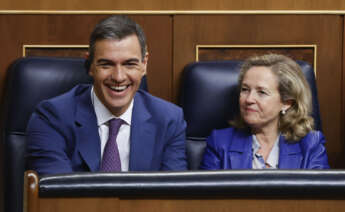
left=3, top=57, right=147, bottom=212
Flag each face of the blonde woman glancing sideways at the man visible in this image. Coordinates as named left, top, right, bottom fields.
left=239, top=66, right=286, bottom=129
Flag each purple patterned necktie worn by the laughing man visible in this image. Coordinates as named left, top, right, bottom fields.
left=101, top=119, right=123, bottom=172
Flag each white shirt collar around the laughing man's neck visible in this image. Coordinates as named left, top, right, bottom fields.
left=91, top=86, right=134, bottom=126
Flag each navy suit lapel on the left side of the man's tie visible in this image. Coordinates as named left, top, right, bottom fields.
left=76, top=86, right=101, bottom=172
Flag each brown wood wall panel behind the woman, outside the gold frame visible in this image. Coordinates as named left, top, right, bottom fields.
left=174, top=15, right=345, bottom=168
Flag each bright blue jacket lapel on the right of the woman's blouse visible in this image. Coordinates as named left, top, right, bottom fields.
left=279, top=136, right=302, bottom=169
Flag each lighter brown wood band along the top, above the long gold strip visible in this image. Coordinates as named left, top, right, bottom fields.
left=0, top=0, right=345, bottom=10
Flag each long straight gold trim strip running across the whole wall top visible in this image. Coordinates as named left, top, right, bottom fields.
left=0, top=10, right=345, bottom=15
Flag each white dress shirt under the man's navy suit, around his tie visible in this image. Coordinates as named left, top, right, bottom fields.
left=91, top=87, right=134, bottom=171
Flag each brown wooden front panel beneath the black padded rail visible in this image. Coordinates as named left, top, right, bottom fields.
left=33, top=197, right=345, bottom=212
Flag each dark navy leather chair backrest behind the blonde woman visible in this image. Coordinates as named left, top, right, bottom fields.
left=179, top=60, right=321, bottom=169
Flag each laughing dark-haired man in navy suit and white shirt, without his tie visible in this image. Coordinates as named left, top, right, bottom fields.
left=27, top=16, right=187, bottom=174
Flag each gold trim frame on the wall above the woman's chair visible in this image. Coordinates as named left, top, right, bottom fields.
left=195, top=44, right=317, bottom=78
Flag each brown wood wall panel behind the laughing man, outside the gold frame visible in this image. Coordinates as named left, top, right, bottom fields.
left=0, top=15, right=172, bottom=104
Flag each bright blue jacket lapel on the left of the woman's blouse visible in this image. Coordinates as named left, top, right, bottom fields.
left=225, top=130, right=253, bottom=169
